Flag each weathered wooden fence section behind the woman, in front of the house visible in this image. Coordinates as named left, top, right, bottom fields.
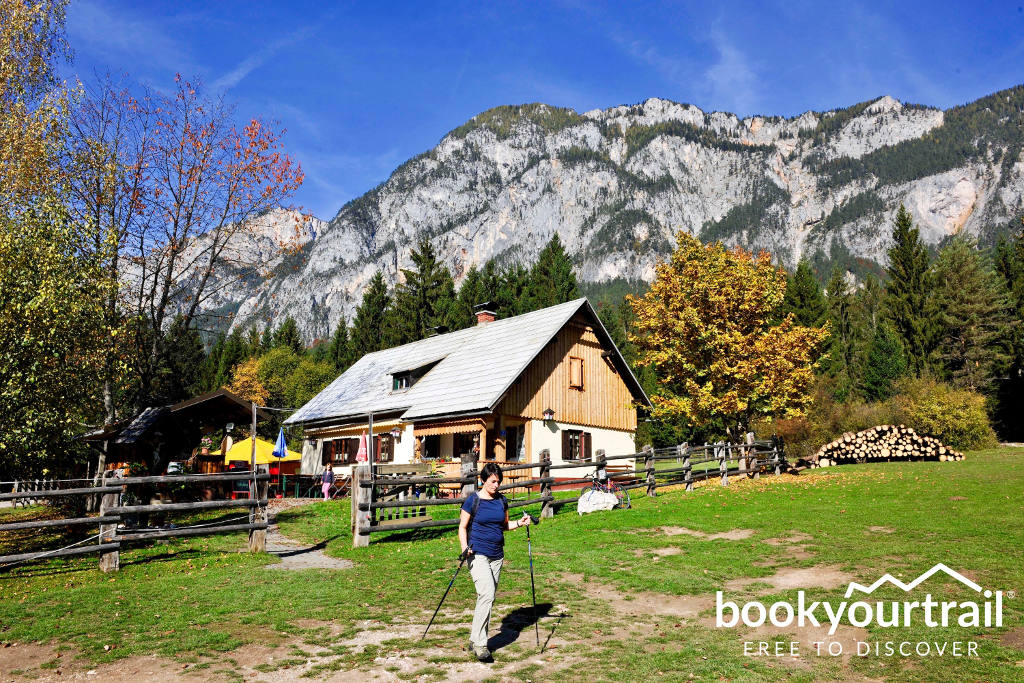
left=352, top=434, right=785, bottom=547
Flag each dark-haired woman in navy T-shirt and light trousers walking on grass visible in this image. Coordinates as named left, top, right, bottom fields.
left=459, top=463, right=529, bottom=661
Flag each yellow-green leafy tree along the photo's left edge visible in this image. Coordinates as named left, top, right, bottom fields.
left=0, top=0, right=111, bottom=479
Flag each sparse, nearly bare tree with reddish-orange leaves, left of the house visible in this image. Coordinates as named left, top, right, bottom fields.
left=131, top=77, right=303, bottom=405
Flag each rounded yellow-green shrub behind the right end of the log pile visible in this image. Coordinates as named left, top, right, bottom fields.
left=893, top=379, right=998, bottom=450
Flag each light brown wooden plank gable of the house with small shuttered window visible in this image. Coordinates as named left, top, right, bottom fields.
left=497, top=314, right=637, bottom=431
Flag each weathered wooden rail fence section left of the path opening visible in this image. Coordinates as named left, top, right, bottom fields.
left=0, top=471, right=270, bottom=571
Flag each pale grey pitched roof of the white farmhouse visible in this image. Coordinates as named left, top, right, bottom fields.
left=285, top=299, right=649, bottom=424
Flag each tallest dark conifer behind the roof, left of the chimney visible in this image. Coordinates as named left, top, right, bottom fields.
left=387, top=238, right=455, bottom=345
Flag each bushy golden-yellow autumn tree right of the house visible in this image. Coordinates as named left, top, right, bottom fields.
left=628, top=231, right=828, bottom=433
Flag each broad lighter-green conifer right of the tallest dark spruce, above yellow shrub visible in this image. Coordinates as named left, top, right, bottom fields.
left=934, top=239, right=1011, bottom=391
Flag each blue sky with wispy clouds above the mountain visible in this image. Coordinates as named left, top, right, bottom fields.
left=66, top=0, right=1024, bottom=219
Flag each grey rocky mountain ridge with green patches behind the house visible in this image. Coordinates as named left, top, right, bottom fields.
left=203, top=86, right=1024, bottom=339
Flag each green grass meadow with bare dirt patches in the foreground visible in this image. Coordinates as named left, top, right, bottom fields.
left=0, top=449, right=1024, bottom=682
